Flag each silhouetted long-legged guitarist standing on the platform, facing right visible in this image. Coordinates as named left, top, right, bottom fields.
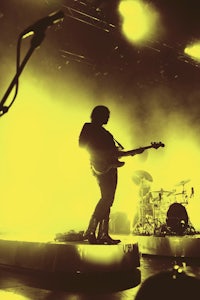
left=79, top=105, right=124, bottom=245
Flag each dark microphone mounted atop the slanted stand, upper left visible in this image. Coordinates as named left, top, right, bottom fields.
left=21, top=10, right=64, bottom=37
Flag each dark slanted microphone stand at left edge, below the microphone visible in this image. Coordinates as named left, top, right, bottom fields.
left=0, top=29, right=45, bottom=117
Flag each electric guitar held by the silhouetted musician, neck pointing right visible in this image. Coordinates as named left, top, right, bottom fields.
left=91, top=142, right=165, bottom=175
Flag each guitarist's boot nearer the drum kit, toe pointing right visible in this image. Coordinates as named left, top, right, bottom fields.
left=97, top=219, right=121, bottom=245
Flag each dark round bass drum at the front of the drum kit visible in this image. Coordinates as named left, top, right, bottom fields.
left=166, top=203, right=188, bottom=235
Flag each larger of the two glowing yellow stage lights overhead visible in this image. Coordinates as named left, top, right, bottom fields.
left=118, top=0, right=158, bottom=44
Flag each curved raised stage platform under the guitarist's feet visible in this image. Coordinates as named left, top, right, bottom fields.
left=0, top=238, right=141, bottom=290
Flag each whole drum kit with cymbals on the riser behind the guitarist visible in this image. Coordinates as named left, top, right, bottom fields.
left=132, top=170, right=196, bottom=236
